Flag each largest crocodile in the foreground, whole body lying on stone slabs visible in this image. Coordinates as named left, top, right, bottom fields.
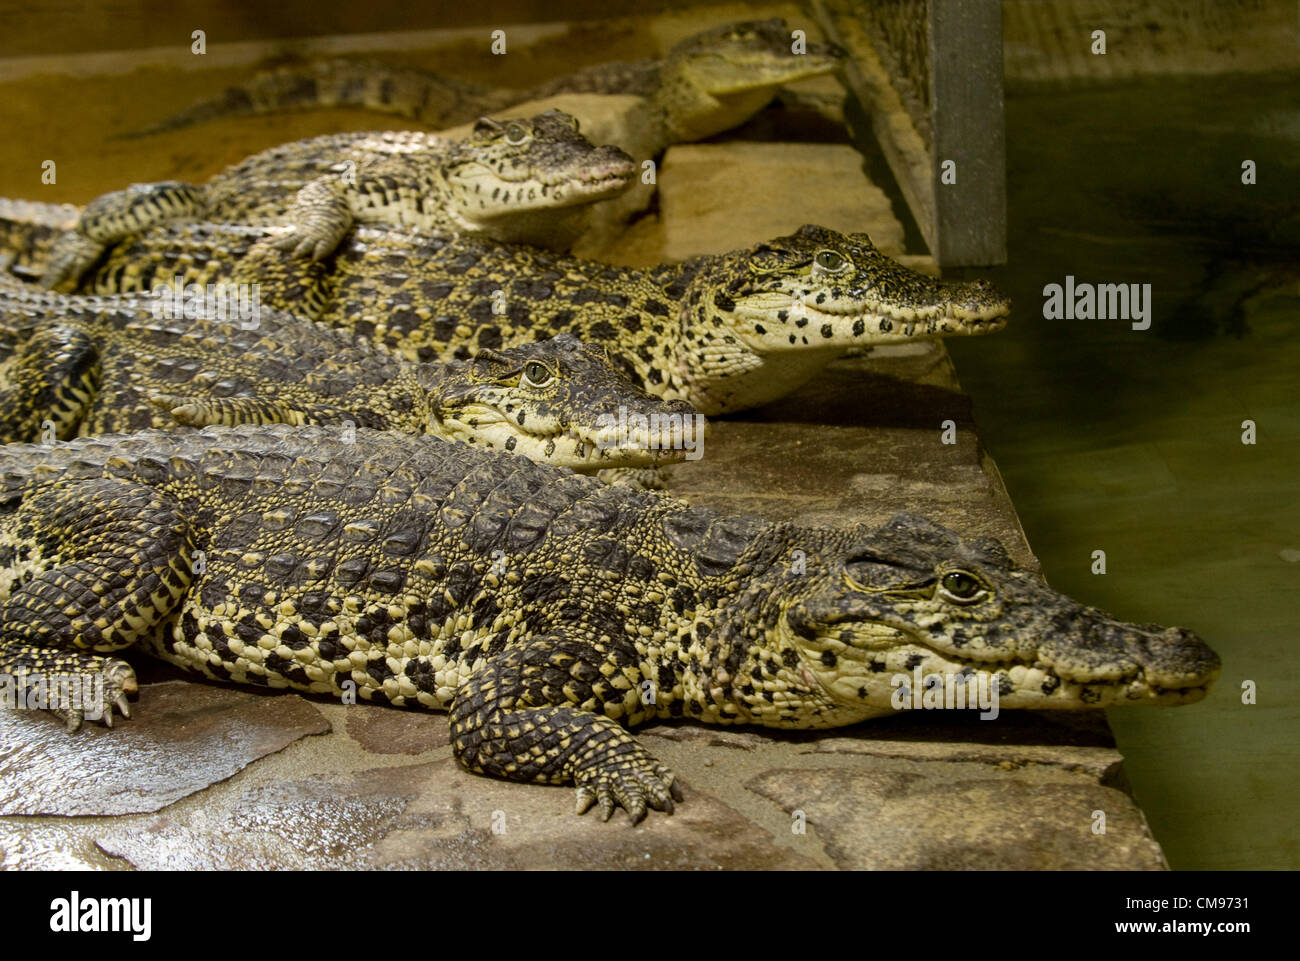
left=0, top=425, right=1219, bottom=823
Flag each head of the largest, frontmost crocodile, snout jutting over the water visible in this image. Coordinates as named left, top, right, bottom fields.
left=733, top=514, right=1219, bottom=723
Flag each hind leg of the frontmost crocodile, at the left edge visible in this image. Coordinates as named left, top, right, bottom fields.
left=0, top=479, right=192, bottom=731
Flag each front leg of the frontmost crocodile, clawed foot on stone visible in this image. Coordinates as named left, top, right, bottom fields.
left=451, top=637, right=681, bottom=823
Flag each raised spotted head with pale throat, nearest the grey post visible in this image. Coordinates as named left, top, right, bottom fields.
left=672, top=225, right=1011, bottom=416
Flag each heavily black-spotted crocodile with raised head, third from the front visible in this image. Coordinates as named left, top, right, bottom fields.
left=35, top=224, right=1010, bottom=416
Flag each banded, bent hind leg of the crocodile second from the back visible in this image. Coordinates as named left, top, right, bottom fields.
left=40, top=181, right=207, bottom=291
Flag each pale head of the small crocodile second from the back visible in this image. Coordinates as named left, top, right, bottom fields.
left=443, top=111, right=636, bottom=243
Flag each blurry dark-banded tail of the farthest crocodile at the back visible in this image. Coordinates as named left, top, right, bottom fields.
left=122, top=59, right=514, bottom=139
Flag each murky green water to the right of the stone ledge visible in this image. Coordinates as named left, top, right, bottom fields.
left=949, top=75, right=1300, bottom=869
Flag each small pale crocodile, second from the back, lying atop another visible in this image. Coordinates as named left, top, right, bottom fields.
left=42, top=111, right=636, bottom=289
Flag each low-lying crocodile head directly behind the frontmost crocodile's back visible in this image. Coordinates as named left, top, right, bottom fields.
left=420, top=334, right=703, bottom=473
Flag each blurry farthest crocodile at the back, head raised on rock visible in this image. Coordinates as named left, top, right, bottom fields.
left=119, top=20, right=844, bottom=256
